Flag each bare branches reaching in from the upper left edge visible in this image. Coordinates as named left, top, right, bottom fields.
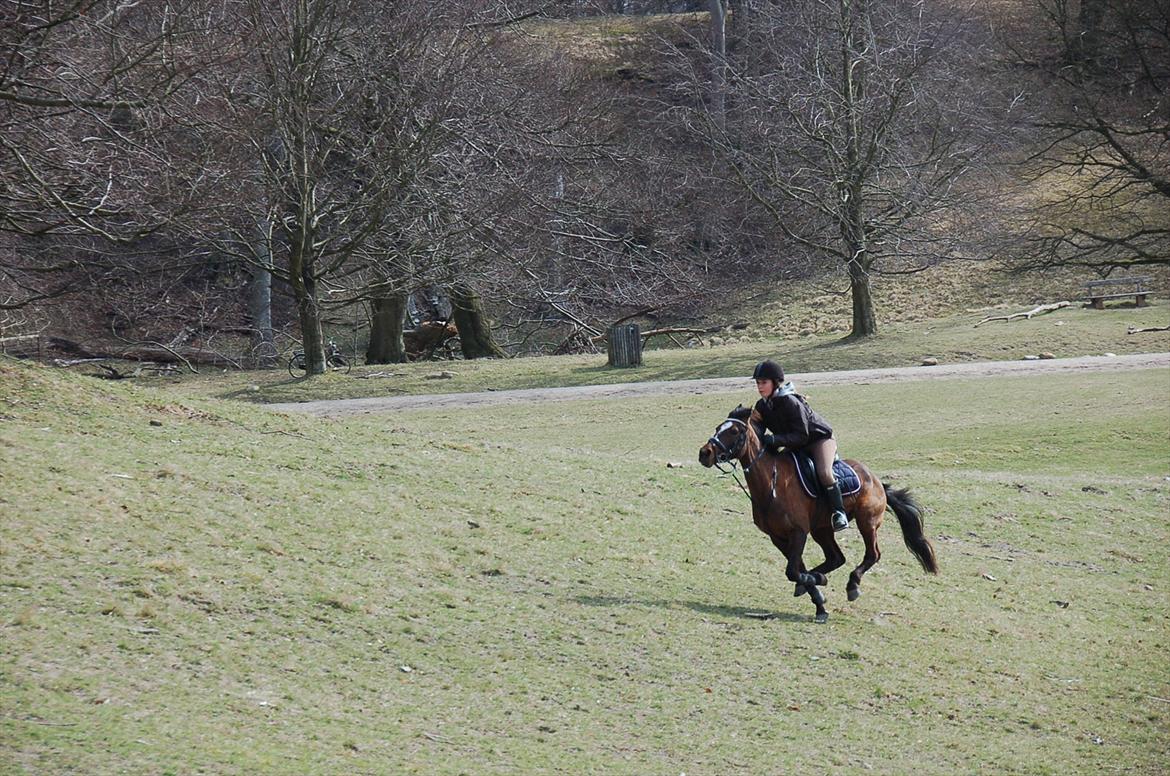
left=0, top=0, right=220, bottom=308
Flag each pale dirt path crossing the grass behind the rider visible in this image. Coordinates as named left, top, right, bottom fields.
left=267, top=353, right=1170, bottom=418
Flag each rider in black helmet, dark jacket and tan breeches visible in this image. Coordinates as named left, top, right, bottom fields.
left=752, top=360, right=849, bottom=531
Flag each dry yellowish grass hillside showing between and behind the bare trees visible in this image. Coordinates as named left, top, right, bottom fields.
left=512, top=0, right=1170, bottom=332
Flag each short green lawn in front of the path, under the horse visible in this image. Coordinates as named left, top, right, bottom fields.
left=0, top=362, right=1170, bottom=775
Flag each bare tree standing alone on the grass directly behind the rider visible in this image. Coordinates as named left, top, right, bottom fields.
left=691, top=0, right=983, bottom=336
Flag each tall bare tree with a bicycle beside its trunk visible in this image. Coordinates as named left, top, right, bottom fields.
left=184, top=0, right=519, bottom=375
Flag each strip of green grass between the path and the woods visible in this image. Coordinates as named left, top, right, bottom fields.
left=146, top=301, right=1170, bottom=403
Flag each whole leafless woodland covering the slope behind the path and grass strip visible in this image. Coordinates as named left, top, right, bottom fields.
left=0, top=0, right=1170, bottom=373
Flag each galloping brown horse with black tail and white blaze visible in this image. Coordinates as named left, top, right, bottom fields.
left=698, top=406, right=938, bottom=623
